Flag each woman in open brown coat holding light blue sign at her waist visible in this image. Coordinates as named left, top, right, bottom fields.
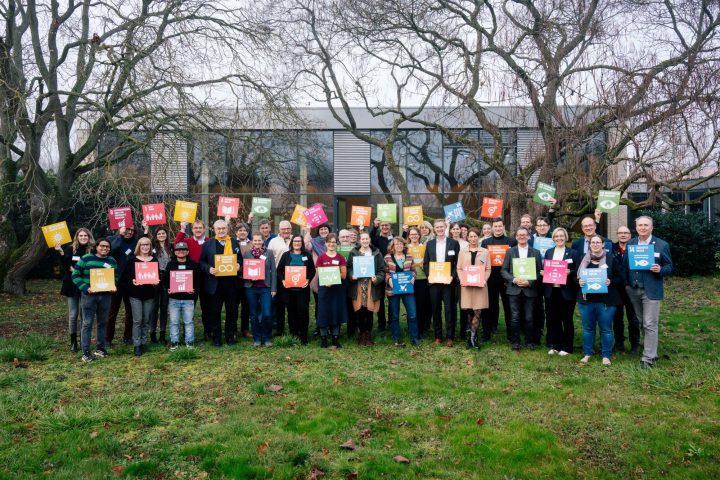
left=347, top=232, right=385, bottom=346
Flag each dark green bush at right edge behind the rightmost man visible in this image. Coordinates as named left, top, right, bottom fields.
left=642, top=210, right=720, bottom=277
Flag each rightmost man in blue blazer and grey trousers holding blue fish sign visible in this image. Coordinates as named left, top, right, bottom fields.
left=625, top=215, right=672, bottom=368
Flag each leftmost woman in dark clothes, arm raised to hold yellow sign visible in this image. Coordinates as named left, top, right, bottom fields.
left=55, top=228, right=95, bottom=353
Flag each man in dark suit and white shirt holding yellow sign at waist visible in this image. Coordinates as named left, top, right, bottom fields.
left=423, top=218, right=460, bottom=347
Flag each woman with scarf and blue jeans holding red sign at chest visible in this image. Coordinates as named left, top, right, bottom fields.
left=243, top=233, right=277, bottom=347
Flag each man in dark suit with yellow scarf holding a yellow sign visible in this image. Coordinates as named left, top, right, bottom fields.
left=200, top=220, right=242, bottom=347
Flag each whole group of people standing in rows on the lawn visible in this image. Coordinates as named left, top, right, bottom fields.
left=56, top=205, right=672, bottom=368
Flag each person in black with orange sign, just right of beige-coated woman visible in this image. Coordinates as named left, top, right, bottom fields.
left=480, top=217, right=517, bottom=342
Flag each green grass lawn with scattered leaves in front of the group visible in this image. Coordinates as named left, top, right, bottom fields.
left=0, top=278, right=720, bottom=480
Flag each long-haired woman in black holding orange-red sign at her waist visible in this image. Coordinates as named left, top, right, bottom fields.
left=277, top=235, right=315, bottom=345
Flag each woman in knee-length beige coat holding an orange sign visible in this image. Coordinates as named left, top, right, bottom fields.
left=457, top=227, right=491, bottom=347
